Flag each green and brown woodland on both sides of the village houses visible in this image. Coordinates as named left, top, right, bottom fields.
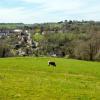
left=0, top=20, right=100, bottom=61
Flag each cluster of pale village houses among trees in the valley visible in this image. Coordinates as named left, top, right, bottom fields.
left=0, top=29, right=38, bottom=56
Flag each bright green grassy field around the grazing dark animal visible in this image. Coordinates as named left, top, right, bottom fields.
left=0, top=57, right=100, bottom=100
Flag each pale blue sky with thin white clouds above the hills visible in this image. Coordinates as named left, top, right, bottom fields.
left=0, top=0, right=100, bottom=24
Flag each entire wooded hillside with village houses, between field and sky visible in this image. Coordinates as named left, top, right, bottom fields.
left=0, top=20, right=100, bottom=61
